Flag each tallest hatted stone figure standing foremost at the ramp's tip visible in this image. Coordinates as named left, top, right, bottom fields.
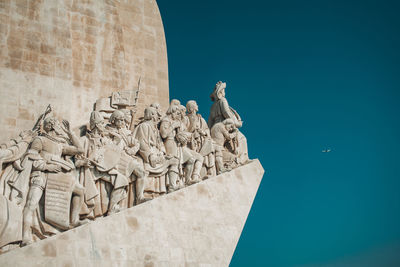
left=208, top=81, right=249, bottom=164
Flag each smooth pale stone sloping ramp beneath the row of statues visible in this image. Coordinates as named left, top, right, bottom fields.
left=0, top=160, right=264, bottom=267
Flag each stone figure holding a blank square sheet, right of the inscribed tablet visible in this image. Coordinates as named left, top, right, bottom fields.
left=75, top=111, right=129, bottom=218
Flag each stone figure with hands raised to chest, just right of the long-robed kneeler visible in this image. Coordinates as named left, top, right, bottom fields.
left=160, top=105, right=203, bottom=187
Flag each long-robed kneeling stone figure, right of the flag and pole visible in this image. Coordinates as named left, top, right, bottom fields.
left=134, top=107, right=179, bottom=198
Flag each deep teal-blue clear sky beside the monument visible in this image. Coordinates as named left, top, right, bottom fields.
left=157, top=0, right=400, bottom=267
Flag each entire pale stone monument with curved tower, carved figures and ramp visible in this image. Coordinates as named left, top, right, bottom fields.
left=0, top=0, right=264, bottom=266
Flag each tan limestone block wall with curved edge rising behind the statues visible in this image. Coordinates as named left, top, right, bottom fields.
left=0, top=0, right=169, bottom=142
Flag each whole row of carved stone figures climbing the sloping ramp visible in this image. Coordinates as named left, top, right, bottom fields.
left=0, top=82, right=249, bottom=252
